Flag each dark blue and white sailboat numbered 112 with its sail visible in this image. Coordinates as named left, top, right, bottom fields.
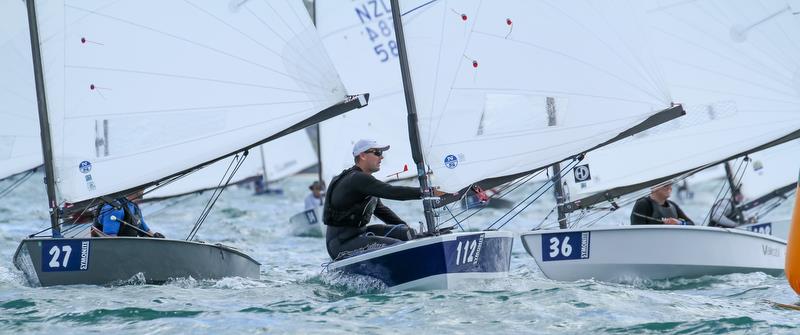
left=327, top=0, right=683, bottom=290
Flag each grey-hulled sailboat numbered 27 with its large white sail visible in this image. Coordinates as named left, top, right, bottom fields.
left=14, top=0, right=368, bottom=286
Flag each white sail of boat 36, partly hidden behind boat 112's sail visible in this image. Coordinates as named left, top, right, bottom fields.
left=568, top=0, right=800, bottom=200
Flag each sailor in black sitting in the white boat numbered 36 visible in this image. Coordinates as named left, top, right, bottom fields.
left=631, top=183, right=694, bottom=225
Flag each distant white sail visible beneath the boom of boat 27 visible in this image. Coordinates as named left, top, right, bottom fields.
left=145, top=130, right=317, bottom=198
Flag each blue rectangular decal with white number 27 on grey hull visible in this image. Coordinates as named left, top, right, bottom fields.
left=41, top=240, right=90, bottom=272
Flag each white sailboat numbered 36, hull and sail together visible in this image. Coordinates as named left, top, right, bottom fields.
left=521, top=1, right=800, bottom=281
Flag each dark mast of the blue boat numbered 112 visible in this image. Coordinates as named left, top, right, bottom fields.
left=391, top=0, right=436, bottom=233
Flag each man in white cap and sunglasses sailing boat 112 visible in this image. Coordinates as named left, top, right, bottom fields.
left=322, top=140, right=444, bottom=259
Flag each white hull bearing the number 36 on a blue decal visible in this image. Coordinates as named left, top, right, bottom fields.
left=521, top=225, right=786, bottom=282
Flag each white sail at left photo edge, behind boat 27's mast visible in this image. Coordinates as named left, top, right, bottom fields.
left=0, top=1, right=42, bottom=179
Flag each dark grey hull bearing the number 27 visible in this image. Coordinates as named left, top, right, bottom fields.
left=14, top=237, right=261, bottom=286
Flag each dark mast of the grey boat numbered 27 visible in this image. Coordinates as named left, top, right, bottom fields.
left=26, top=0, right=61, bottom=237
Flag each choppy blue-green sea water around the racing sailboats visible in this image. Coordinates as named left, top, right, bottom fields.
left=0, top=175, right=800, bottom=334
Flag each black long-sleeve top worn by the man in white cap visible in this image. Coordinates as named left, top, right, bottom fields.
left=329, top=167, right=422, bottom=224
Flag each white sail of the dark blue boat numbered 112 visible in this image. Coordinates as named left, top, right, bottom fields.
left=400, top=0, right=671, bottom=192
